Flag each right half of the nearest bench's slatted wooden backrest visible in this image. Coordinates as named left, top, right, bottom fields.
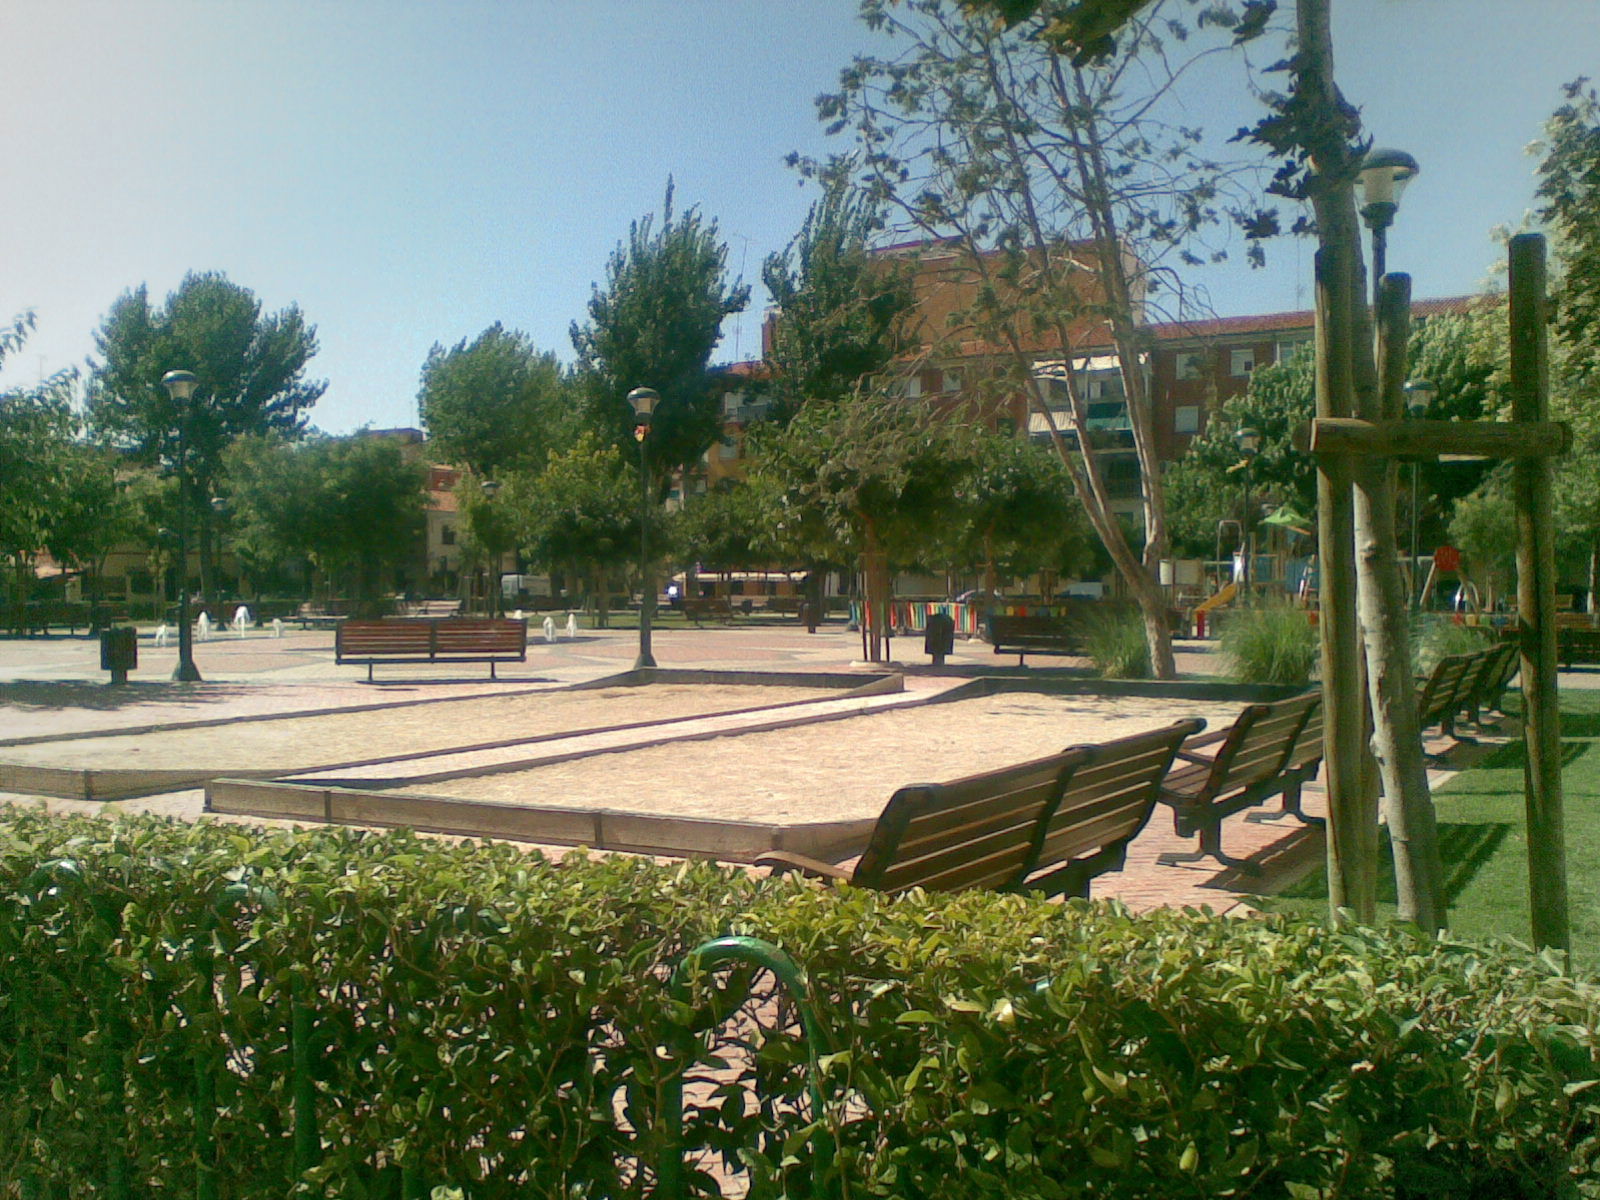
left=1034, top=718, right=1205, bottom=869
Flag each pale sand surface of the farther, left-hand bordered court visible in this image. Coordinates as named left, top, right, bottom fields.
left=0, top=683, right=837, bottom=771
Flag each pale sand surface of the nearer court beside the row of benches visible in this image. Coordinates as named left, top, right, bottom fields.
left=386, top=693, right=1240, bottom=821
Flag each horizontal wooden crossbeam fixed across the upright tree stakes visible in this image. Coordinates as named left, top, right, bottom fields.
left=1294, top=416, right=1573, bottom=459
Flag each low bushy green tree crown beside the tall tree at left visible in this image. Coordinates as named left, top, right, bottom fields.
left=226, top=434, right=427, bottom=602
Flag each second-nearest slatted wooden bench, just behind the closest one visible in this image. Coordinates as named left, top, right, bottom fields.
left=1158, top=691, right=1322, bottom=875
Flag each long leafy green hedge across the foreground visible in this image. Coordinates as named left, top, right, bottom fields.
left=0, top=811, right=1600, bottom=1200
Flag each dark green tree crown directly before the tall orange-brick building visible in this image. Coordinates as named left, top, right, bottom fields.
left=762, top=179, right=917, bottom=421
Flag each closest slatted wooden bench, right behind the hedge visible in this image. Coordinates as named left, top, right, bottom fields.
left=757, top=720, right=1205, bottom=896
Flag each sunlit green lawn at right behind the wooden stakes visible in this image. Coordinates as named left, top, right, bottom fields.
left=1262, top=691, right=1600, bottom=968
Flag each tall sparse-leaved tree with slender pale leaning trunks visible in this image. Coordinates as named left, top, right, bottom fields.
left=818, top=0, right=1267, bottom=678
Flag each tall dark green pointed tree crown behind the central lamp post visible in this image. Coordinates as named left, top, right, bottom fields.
left=571, top=179, right=750, bottom=483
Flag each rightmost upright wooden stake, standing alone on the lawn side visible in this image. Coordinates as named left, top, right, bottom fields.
left=1510, top=234, right=1571, bottom=950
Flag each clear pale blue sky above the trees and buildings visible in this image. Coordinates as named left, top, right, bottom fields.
left=0, top=0, right=1600, bottom=432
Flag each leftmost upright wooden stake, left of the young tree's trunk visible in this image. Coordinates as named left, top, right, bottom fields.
left=1315, top=248, right=1378, bottom=922
